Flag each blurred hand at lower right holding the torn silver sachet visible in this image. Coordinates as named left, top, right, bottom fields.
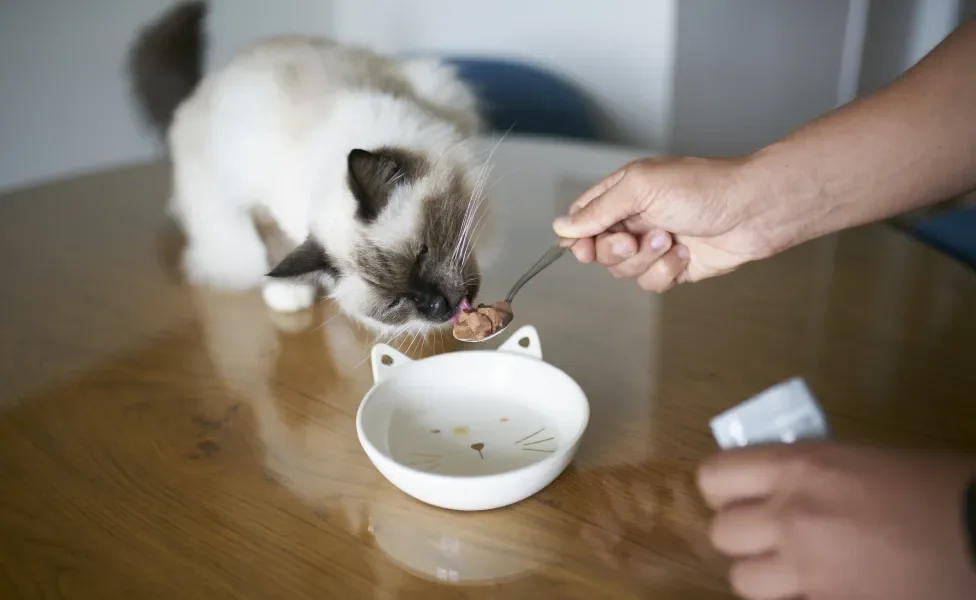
left=698, top=443, right=976, bottom=600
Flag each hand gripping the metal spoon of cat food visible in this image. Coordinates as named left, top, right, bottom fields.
left=553, top=158, right=770, bottom=292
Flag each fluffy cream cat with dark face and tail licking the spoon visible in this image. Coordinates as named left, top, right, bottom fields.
left=129, top=1, right=491, bottom=332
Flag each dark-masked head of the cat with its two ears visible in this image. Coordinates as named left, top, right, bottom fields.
left=270, top=148, right=487, bottom=331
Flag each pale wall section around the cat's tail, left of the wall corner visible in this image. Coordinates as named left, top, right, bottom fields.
left=0, top=0, right=332, bottom=190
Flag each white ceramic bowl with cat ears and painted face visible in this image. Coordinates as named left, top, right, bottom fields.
left=356, top=326, right=590, bottom=511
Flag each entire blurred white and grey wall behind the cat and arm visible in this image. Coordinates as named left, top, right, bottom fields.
left=0, top=0, right=968, bottom=190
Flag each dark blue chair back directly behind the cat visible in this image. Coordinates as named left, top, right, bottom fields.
left=444, top=58, right=602, bottom=140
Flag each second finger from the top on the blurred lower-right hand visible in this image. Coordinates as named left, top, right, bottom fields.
left=709, top=501, right=780, bottom=557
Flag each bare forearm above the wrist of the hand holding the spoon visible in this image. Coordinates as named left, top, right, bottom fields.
left=737, top=20, right=976, bottom=254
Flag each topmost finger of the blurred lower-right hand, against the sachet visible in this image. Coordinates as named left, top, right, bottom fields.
left=698, top=445, right=782, bottom=509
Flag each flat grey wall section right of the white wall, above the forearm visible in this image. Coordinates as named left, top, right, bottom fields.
left=670, top=0, right=850, bottom=156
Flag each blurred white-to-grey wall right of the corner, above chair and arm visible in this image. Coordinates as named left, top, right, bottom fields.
left=335, top=0, right=960, bottom=155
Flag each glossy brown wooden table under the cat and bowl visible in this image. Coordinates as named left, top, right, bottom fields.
left=0, top=139, right=976, bottom=600
